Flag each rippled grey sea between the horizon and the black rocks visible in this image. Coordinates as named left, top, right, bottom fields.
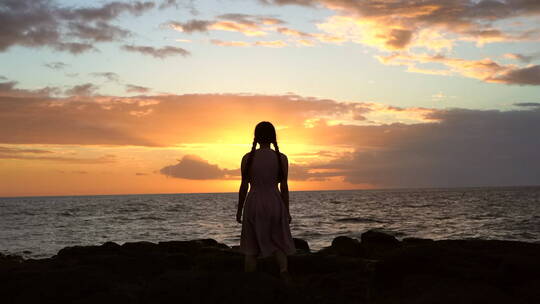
left=0, top=187, right=540, bottom=258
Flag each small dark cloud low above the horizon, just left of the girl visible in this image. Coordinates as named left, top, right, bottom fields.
left=159, top=155, right=239, bottom=180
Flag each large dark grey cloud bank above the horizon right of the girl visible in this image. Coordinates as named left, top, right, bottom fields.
left=298, top=108, right=540, bottom=188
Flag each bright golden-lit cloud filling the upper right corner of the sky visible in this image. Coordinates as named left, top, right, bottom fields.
left=260, top=0, right=540, bottom=85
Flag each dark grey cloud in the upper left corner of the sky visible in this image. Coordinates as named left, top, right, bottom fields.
left=0, top=0, right=154, bottom=54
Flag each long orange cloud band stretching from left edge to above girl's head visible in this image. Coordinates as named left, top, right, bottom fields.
left=0, top=91, right=372, bottom=146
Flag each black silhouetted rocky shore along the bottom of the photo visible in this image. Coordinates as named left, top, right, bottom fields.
left=0, top=231, right=540, bottom=304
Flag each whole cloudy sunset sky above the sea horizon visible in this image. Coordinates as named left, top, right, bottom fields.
left=0, top=0, right=540, bottom=196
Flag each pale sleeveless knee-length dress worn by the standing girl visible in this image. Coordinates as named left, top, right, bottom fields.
left=240, top=148, right=296, bottom=257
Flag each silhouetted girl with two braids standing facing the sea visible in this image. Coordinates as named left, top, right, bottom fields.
left=236, top=121, right=295, bottom=279
